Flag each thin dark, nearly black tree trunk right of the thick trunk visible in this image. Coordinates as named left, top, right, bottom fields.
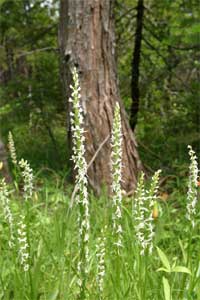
left=130, top=0, right=144, bottom=130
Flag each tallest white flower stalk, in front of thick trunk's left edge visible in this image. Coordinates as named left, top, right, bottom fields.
left=69, top=68, right=90, bottom=299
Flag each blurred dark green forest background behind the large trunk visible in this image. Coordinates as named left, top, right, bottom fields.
left=0, top=0, right=200, bottom=193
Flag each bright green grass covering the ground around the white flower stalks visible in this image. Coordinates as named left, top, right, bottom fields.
left=0, top=177, right=200, bottom=300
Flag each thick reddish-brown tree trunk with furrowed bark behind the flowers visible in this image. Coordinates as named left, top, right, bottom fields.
left=59, top=0, right=141, bottom=192
